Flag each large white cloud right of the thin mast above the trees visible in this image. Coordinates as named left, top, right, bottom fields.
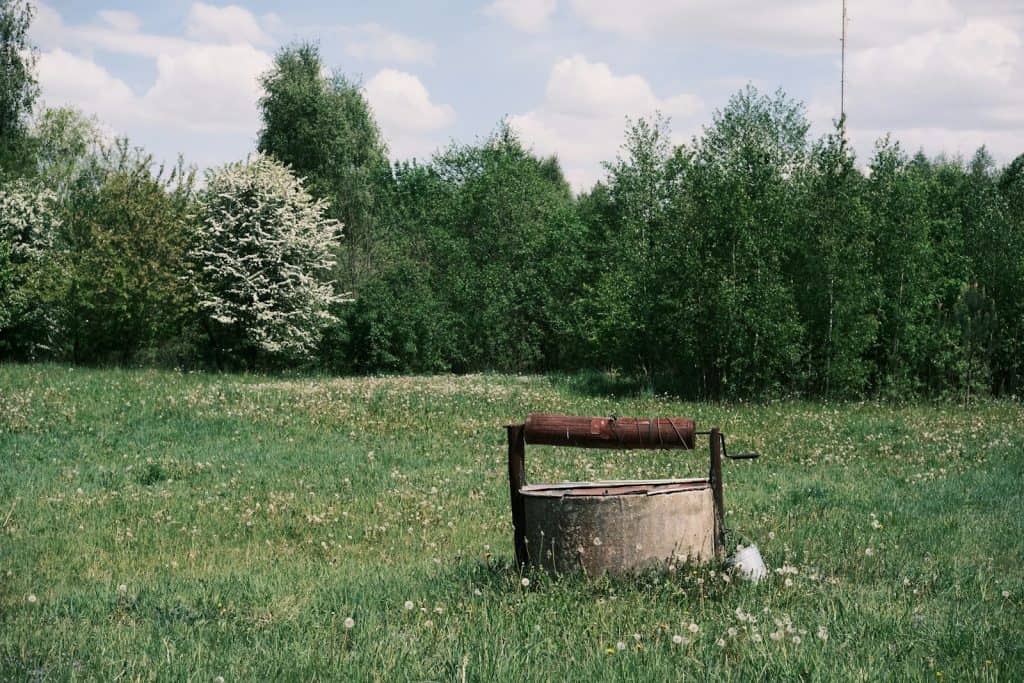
left=809, top=18, right=1024, bottom=163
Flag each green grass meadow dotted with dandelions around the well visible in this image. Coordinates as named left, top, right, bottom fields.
left=0, top=366, right=1024, bottom=681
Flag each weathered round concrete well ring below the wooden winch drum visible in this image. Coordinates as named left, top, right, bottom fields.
left=521, top=479, right=715, bottom=575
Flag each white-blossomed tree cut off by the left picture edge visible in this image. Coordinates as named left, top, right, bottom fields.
left=0, top=181, right=59, bottom=356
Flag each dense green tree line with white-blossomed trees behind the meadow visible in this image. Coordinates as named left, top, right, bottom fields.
left=0, top=0, right=1024, bottom=397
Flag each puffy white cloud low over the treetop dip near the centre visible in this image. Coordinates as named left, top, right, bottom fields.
left=509, top=55, right=703, bottom=189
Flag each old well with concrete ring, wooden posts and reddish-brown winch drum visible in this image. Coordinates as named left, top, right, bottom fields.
left=508, top=414, right=741, bottom=575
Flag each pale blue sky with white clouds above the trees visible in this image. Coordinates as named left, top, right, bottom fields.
left=31, top=0, right=1024, bottom=190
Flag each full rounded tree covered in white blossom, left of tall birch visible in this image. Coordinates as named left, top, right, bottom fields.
left=191, top=155, right=344, bottom=366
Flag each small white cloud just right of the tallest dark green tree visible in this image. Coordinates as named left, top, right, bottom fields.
left=365, top=69, right=455, bottom=158
